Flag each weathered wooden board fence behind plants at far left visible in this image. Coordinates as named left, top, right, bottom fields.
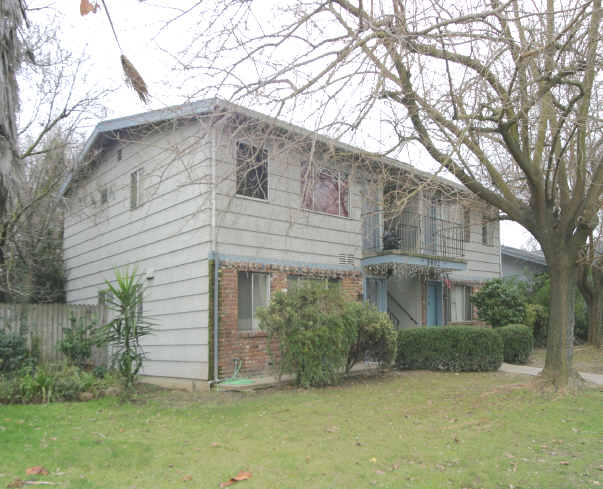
left=0, top=303, right=108, bottom=365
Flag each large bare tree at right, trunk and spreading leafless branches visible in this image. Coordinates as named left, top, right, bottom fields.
left=171, top=0, right=603, bottom=388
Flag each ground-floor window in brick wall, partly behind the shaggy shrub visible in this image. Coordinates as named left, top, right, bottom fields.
left=238, top=272, right=270, bottom=331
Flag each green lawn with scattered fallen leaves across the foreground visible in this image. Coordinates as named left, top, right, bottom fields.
left=0, top=372, right=603, bottom=489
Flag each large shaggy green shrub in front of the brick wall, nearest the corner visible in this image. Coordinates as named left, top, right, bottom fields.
left=257, top=283, right=356, bottom=387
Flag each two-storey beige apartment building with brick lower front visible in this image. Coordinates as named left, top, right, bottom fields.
left=64, top=99, right=500, bottom=386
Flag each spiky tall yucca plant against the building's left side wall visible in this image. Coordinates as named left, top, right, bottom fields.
left=104, top=269, right=152, bottom=392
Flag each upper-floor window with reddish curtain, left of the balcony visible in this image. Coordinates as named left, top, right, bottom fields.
left=301, top=162, right=350, bottom=217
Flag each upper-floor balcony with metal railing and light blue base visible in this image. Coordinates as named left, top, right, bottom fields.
left=363, top=212, right=466, bottom=270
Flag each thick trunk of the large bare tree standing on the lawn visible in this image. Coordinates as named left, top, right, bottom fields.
left=542, top=248, right=577, bottom=388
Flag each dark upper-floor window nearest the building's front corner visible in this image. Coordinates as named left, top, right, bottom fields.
left=236, top=142, right=268, bottom=200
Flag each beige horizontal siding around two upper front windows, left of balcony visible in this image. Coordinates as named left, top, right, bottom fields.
left=216, top=124, right=362, bottom=267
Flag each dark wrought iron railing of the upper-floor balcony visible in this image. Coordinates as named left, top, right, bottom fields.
left=365, top=212, right=464, bottom=258
